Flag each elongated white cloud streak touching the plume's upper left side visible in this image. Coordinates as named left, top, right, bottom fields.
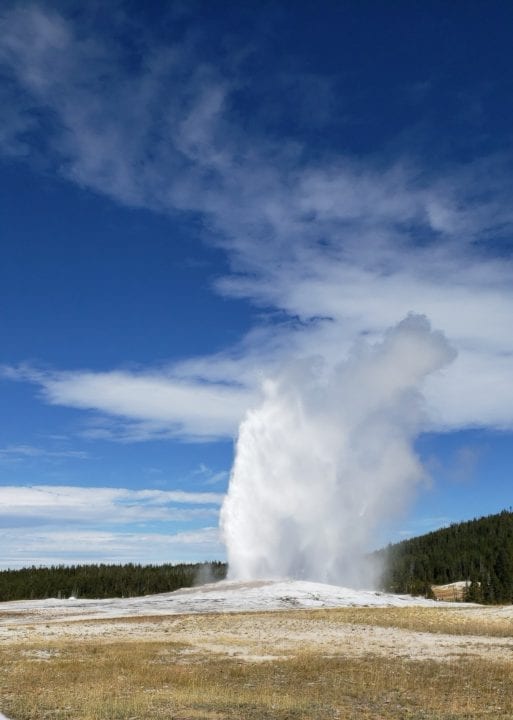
left=0, top=367, right=252, bottom=442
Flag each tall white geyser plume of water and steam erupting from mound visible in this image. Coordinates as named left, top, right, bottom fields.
left=221, top=315, right=455, bottom=585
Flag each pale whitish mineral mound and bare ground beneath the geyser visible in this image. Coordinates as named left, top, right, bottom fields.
left=0, top=581, right=513, bottom=662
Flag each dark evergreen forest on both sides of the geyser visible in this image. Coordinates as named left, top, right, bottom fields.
left=0, top=510, right=513, bottom=603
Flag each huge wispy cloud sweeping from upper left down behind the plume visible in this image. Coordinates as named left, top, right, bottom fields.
left=0, top=5, right=513, bottom=440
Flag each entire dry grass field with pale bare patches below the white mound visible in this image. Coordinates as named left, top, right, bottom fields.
left=0, top=607, right=513, bottom=720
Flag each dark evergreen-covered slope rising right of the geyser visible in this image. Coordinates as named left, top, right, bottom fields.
left=376, top=510, right=513, bottom=603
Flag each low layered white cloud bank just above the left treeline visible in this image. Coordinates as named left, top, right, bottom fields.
left=0, top=485, right=224, bottom=568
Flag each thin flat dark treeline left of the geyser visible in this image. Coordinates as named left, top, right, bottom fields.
left=0, top=562, right=227, bottom=601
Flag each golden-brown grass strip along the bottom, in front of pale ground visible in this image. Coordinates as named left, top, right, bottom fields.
left=1, top=642, right=513, bottom=720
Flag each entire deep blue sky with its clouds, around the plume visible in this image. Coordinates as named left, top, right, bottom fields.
left=0, top=0, right=513, bottom=567
